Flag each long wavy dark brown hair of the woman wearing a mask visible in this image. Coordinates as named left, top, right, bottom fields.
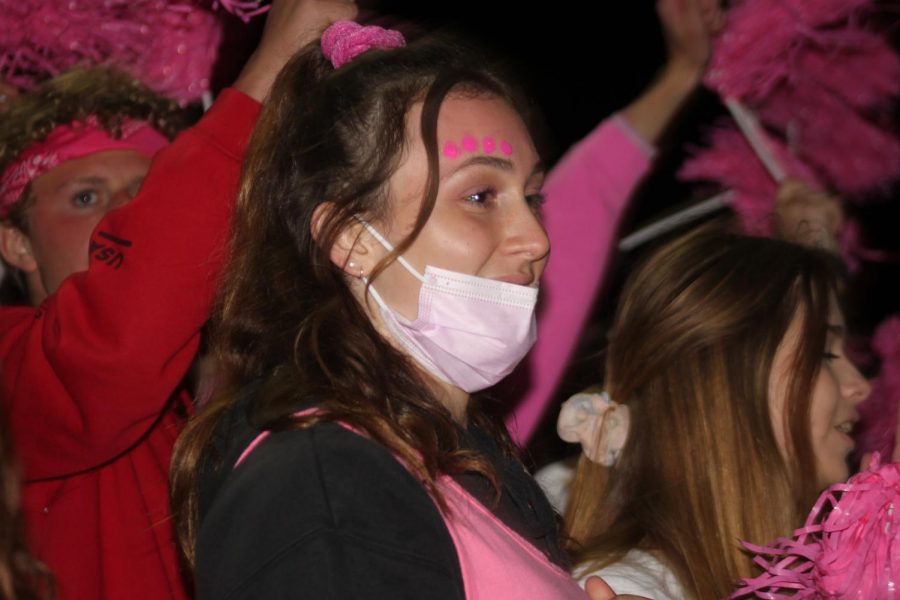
left=171, top=38, right=532, bottom=563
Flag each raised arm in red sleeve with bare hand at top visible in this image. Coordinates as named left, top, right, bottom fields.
left=0, top=0, right=355, bottom=480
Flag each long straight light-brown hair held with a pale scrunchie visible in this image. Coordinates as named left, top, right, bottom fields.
left=566, top=223, right=841, bottom=599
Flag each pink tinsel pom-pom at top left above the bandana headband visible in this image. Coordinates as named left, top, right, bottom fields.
left=0, top=0, right=265, bottom=104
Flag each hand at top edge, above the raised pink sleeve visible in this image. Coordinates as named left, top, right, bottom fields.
left=656, top=0, right=722, bottom=79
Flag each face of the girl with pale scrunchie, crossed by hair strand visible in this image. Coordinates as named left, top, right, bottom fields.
left=769, top=301, right=870, bottom=489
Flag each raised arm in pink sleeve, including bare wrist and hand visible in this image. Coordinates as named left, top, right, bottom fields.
left=507, top=0, right=720, bottom=444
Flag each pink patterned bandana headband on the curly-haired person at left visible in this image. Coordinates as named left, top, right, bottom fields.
left=0, top=117, right=169, bottom=219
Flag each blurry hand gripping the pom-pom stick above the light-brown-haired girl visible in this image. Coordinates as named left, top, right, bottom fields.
left=774, top=178, right=844, bottom=251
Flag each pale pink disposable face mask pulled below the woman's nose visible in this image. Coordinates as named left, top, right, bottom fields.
left=360, top=219, right=538, bottom=393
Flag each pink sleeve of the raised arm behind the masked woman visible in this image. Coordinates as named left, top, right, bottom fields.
left=507, top=115, right=654, bottom=445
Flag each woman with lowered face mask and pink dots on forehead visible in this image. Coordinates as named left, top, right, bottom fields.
left=173, top=22, right=596, bottom=599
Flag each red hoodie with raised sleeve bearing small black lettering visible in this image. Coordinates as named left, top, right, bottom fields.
left=0, top=90, right=259, bottom=600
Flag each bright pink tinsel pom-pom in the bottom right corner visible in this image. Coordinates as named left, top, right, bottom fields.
left=731, top=454, right=900, bottom=600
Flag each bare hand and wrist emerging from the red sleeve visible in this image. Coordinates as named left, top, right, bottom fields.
left=234, top=0, right=357, bottom=102
